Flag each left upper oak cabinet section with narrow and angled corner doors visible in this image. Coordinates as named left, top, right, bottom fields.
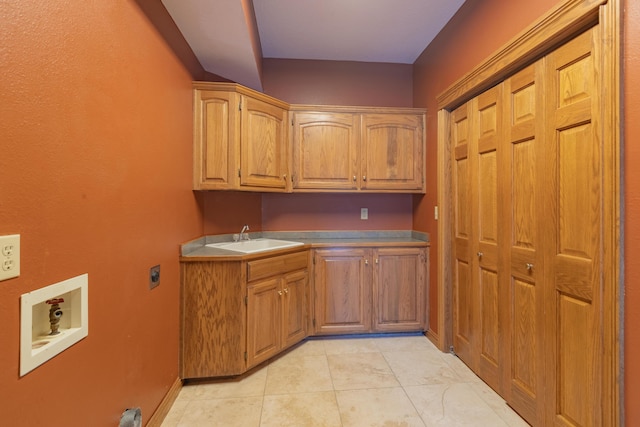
left=193, top=82, right=290, bottom=192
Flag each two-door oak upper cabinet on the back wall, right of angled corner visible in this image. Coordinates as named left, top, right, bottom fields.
left=290, top=106, right=426, bottom=193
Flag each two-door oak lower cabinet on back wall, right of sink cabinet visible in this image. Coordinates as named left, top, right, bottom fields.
left=313, top=247, right=428, bottom=335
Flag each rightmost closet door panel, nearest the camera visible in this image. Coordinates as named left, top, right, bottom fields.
left=544, top=27, right=605, bottom=426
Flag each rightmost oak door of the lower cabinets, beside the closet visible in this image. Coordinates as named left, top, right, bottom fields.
left=373, top=248, right=426, bottom=331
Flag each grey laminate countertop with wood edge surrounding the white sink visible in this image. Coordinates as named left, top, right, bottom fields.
left=180, top=230, right=430, bottom=262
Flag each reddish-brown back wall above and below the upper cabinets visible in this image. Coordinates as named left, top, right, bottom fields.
left=255, top=59, right=413, bottom=231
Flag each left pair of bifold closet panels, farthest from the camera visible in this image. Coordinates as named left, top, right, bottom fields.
left=451, top=85, right=508, bottom=391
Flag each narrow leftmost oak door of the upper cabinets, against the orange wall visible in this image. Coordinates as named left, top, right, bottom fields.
left=193, top=90, right=239, bottom=190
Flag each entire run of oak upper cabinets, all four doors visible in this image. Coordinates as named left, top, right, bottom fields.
left=193, top=82, right=426, bottom=193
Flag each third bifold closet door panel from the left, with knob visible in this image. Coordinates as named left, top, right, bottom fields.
left=500, top=60, right=548, bottom=425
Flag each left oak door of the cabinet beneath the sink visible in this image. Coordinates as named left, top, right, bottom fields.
left=247, top=277, right=282, bottom=367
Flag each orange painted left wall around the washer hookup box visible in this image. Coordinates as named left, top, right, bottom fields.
left=0, top=0, right=202, bottom=426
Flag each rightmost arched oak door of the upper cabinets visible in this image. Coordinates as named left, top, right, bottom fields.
left=361, top=114, right=425, bottom=192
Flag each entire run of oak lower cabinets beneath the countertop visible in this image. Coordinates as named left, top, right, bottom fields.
left=180, top=245, right=428, bottom=379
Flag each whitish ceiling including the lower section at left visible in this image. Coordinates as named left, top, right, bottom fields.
left=162, top=0, right=464, bottom=90
